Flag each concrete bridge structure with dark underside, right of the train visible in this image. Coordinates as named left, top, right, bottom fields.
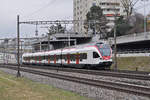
left=108, top=32, right=150, bottom=53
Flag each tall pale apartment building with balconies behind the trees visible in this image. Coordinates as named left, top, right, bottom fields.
left=73, top=0, right=125, bottom=34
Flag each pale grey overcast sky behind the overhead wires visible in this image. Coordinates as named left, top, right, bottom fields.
left=0, top=0, right=150, bottom=38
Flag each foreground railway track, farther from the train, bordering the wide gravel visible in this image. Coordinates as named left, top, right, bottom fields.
left=0, top=66, right=150, bottom=98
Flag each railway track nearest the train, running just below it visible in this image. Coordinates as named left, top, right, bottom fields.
left=2, top=65, right=150, bottom=81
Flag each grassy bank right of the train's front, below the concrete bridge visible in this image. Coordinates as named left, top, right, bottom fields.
left=112, top=57, right=150, bottom=71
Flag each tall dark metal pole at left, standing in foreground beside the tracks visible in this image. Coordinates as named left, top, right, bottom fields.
left=17, top=15, right=21, bottom=77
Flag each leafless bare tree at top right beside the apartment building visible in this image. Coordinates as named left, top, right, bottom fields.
left=121, top=0, right=139, bottom=17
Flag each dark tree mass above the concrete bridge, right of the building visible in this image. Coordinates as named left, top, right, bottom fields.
left=108, top=13, right=144, bottom=37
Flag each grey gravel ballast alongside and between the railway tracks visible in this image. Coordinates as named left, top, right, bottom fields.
left=0, top=68, right=150, bottom=100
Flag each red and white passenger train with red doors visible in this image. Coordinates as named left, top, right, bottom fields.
left=22, top=43, right=112, bottom=68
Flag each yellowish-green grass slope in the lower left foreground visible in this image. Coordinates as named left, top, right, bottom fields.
left=0, top=71, right=90, bottom=100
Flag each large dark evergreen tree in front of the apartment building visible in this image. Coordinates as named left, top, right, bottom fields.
left=84, top=6, right=107, bottom=38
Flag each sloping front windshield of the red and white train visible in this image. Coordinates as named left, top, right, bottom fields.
left=97, top=44, right=111, bottom=56
